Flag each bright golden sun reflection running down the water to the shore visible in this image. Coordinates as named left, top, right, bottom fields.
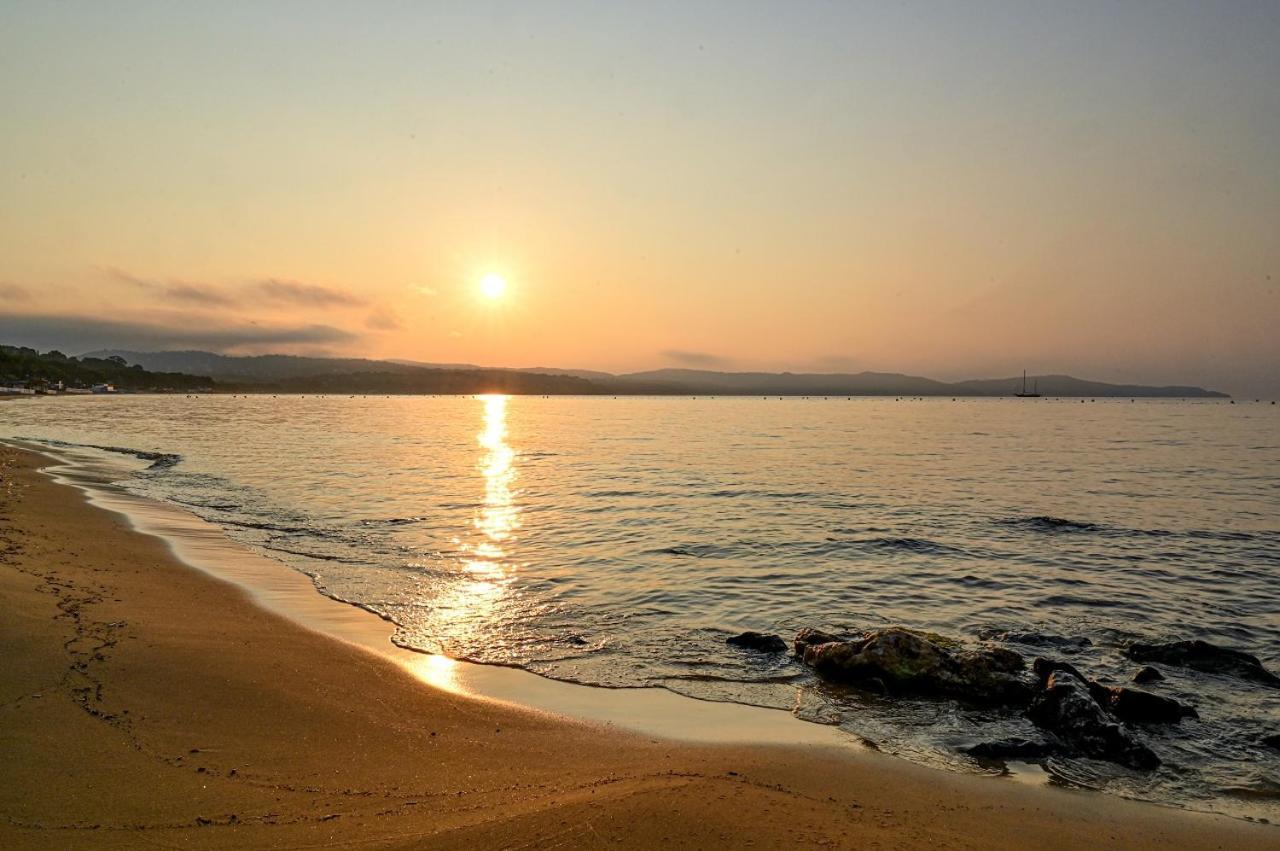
left=417, top=395, right=520, bottom=688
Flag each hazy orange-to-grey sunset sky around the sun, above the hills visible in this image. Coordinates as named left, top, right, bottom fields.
left=0, top=0, right=1280, bottom=393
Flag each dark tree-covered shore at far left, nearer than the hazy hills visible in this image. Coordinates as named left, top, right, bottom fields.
left=0, top=346, right=214, bottom=390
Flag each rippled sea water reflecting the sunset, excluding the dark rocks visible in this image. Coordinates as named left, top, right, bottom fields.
left=0, top=397, right=1280, bottom=820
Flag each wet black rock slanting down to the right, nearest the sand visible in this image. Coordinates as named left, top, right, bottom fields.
left=1027, top=671, right=1160, bottom=770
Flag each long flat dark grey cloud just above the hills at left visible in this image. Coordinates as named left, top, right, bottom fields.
left=0, top=314, right=360, bottom=353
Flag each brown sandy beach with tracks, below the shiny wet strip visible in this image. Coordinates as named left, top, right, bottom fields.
left=0, top=449, right=1280, bottom=848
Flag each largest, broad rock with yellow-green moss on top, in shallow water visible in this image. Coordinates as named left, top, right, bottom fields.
left=796, top=627, right=1030, bottom=704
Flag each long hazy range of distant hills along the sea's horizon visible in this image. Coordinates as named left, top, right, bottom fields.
left=86, top=351, right=1226, bottom=398
